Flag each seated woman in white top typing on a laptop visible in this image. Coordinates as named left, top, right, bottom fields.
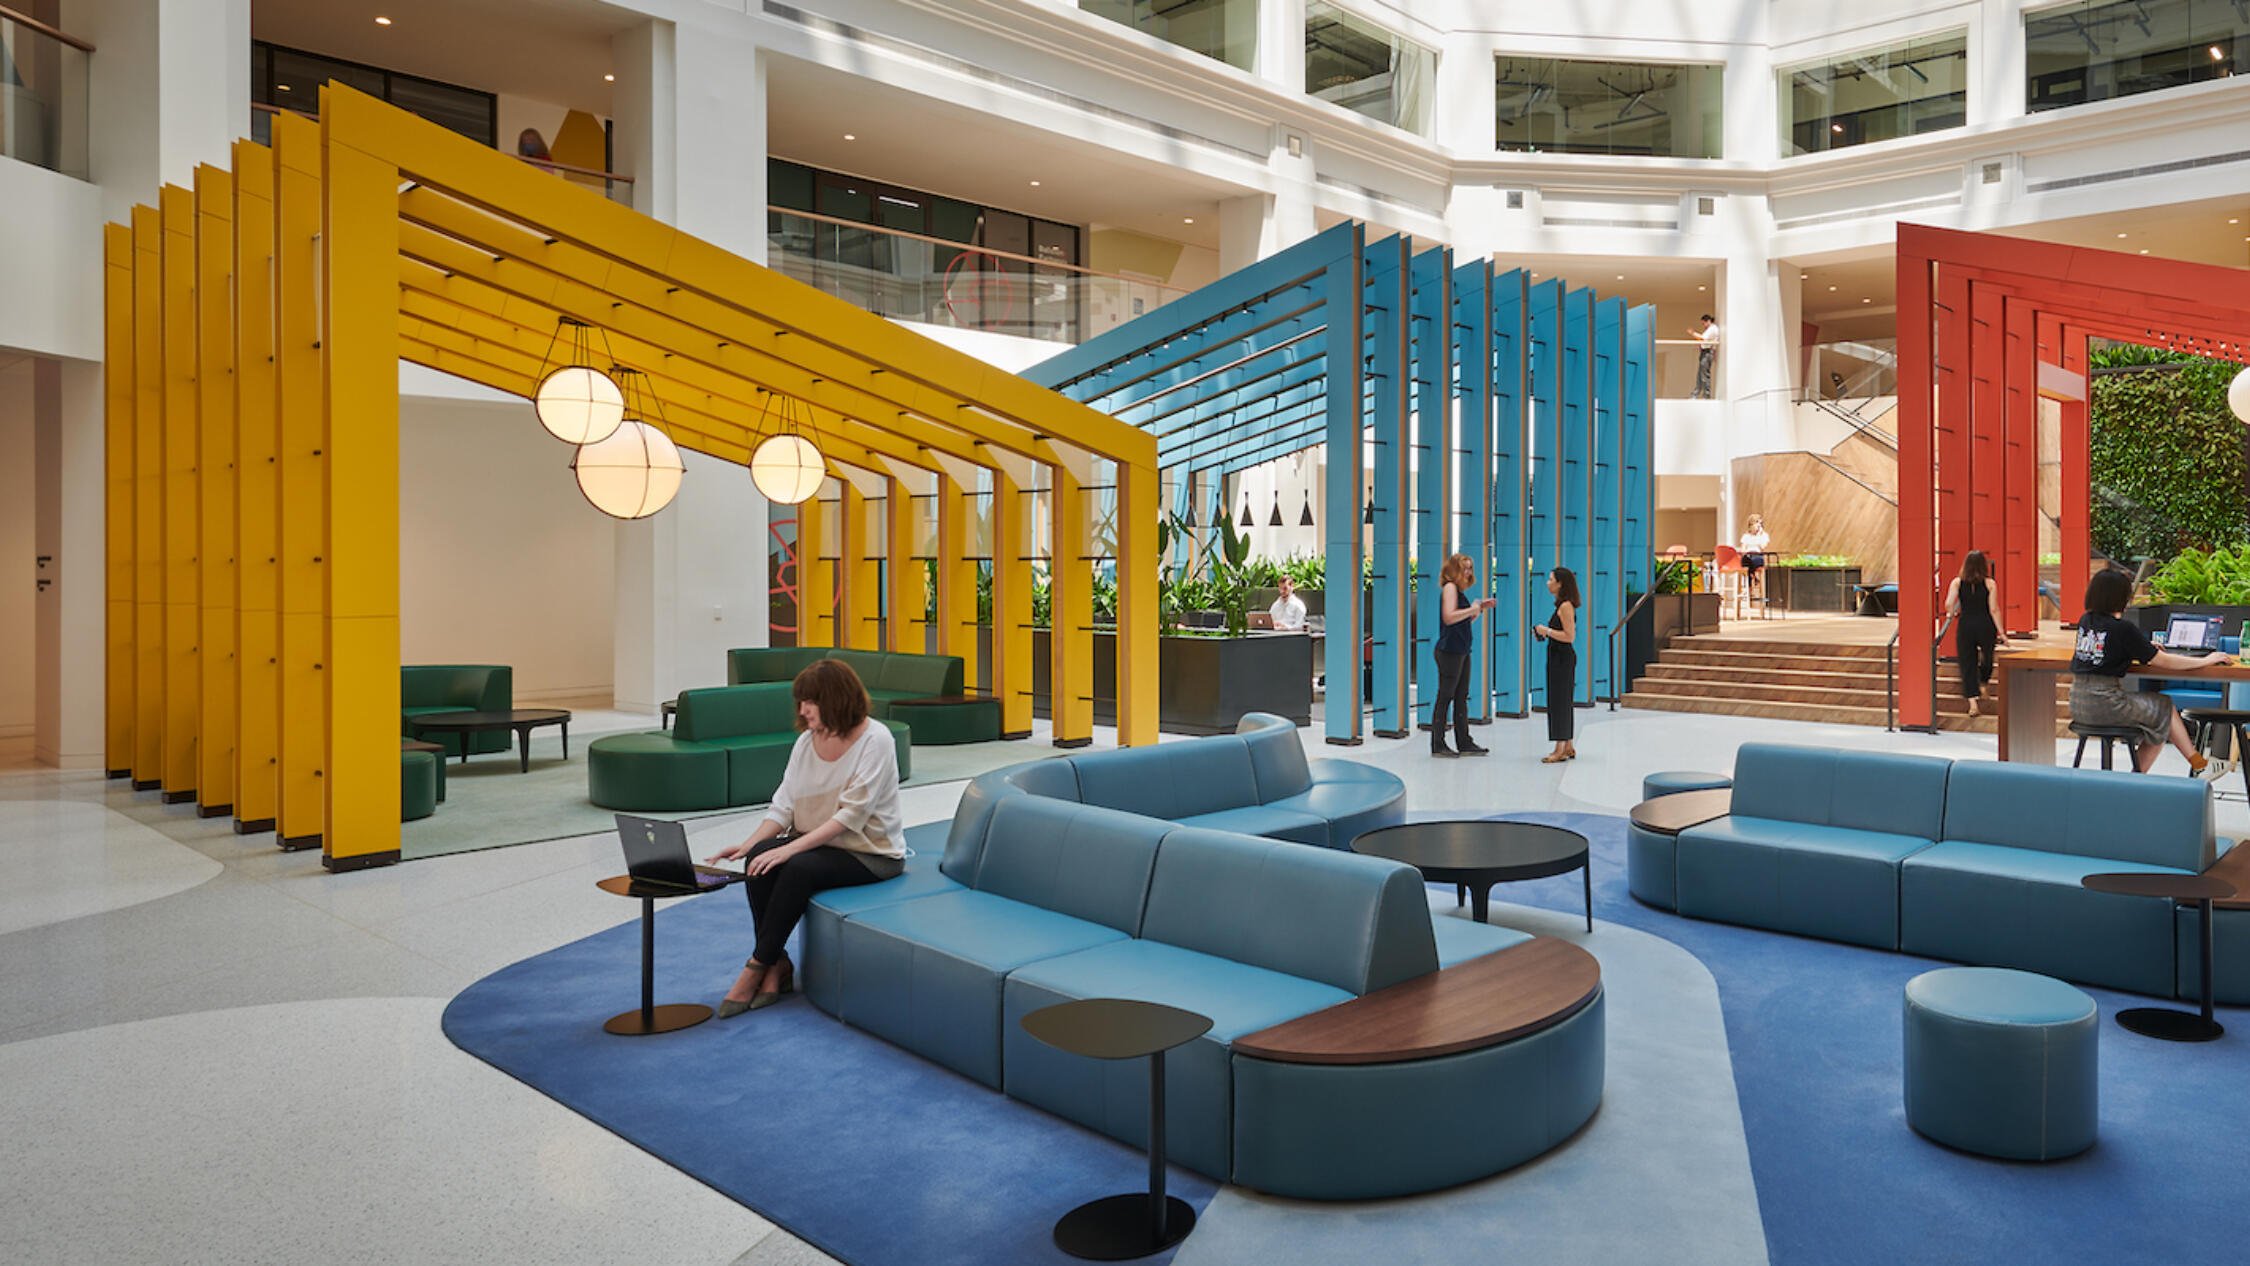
left=709, top=659, right=907, bottom=1019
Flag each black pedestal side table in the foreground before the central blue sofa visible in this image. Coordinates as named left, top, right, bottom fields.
left=1022, top=998, right=1211, bottom=1262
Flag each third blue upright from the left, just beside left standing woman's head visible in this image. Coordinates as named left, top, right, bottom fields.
left=1411, top=247, right=1483, bottom=724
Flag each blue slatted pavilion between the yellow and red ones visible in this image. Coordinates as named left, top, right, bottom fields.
left=1024, top=223, right=1654, bottom=744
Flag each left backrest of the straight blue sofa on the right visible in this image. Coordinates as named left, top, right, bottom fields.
left=1733, top=742, right=1953, bottom=839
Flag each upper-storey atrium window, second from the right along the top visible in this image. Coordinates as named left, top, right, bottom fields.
left=1782, top=31, right=1969, bottom=153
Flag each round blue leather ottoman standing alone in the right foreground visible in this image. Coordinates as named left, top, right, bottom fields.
left=1906, top=967, right=2102, bottom=1160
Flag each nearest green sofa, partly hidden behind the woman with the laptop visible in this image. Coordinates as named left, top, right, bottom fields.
left=585, top=681, right=914, bottom=812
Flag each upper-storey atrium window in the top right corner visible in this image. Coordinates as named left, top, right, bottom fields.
left=2023, top=0, right=2250, bottom=110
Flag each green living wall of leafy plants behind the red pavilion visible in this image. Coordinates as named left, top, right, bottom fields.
left=2090, top=344, right=2250, bottom=562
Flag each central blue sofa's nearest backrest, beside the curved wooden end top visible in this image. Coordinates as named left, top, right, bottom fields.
left=1141, top=832, right=1438, bottom=994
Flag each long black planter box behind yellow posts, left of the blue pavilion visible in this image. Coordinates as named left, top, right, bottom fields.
left=977, top=627, right=1312, bottom=735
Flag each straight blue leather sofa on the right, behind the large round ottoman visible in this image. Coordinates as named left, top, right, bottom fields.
left=1629, top=744, right=2212, bottom=994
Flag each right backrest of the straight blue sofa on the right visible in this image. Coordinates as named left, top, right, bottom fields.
left=1944, top=760, right=2212, bottom=870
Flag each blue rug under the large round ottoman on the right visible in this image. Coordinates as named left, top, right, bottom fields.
left=1467, top=812, right=2250, bottom=1266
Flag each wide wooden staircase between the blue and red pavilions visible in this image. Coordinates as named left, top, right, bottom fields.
left=1622, top=634, right=1998, bottom=733
